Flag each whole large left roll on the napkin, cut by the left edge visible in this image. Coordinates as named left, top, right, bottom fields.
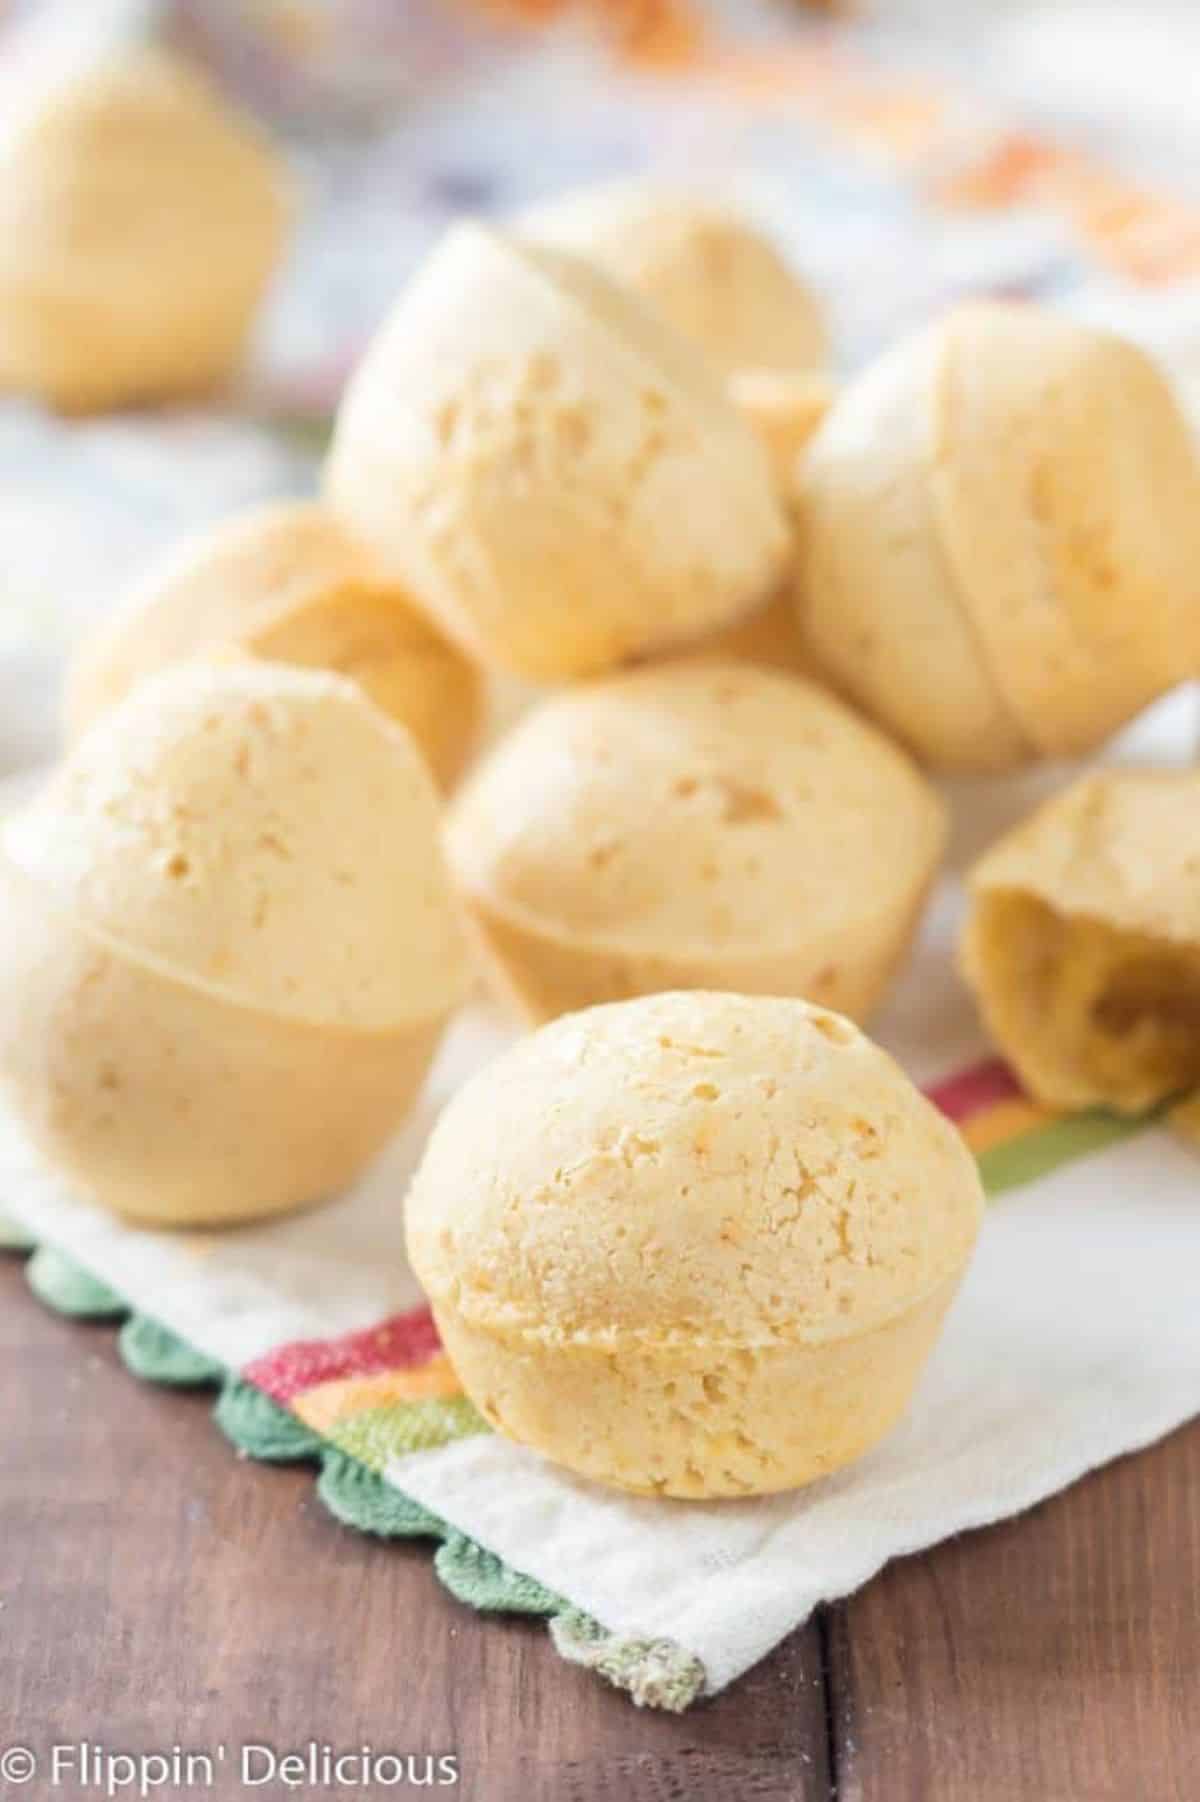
left=0, top=663, right=465, bottom=1225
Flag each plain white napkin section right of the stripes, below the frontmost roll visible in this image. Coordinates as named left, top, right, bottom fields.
left=389, top=1132, right=1200, bottom=1690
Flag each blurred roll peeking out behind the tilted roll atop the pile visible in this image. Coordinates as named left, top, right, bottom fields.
left=517, top=182, right=829, bottom=378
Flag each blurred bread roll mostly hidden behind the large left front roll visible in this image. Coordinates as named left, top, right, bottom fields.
left=67, top=501, right=483, bottom=787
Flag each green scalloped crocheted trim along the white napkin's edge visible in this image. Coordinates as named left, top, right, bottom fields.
left=14, top=1236, right=705, bottom=1710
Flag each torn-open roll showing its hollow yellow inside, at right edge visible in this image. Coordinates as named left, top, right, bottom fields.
left=962, top=769, right=1200, bottom=1114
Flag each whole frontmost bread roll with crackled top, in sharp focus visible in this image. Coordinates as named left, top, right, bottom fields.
left=407, top=993, right=982, bottom=1497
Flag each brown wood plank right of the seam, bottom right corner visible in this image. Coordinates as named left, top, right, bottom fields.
left=827, top=1424, right=1200, bottom=1802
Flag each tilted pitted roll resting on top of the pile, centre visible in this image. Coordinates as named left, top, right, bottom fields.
left=328, top=225, right=791, bottom=679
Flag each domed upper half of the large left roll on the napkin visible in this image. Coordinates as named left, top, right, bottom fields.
left=4, top=663, right=465, bottom=1031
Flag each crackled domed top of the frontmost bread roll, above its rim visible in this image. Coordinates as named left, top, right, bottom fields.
left=407, top=991, right=982, bottom=1348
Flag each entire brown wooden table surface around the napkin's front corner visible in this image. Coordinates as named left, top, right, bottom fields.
left=0, top=1258, right=1200, bottom=1802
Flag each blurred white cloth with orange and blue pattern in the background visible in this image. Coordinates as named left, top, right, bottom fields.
left=0, top=0, right=1200, bottom=769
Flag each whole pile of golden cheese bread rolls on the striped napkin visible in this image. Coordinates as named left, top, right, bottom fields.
left=0, top=162, right=1200, bottom=1496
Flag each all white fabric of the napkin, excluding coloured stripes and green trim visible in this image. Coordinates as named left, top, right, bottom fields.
left=0, top=694, right=1200, bottom=1699
